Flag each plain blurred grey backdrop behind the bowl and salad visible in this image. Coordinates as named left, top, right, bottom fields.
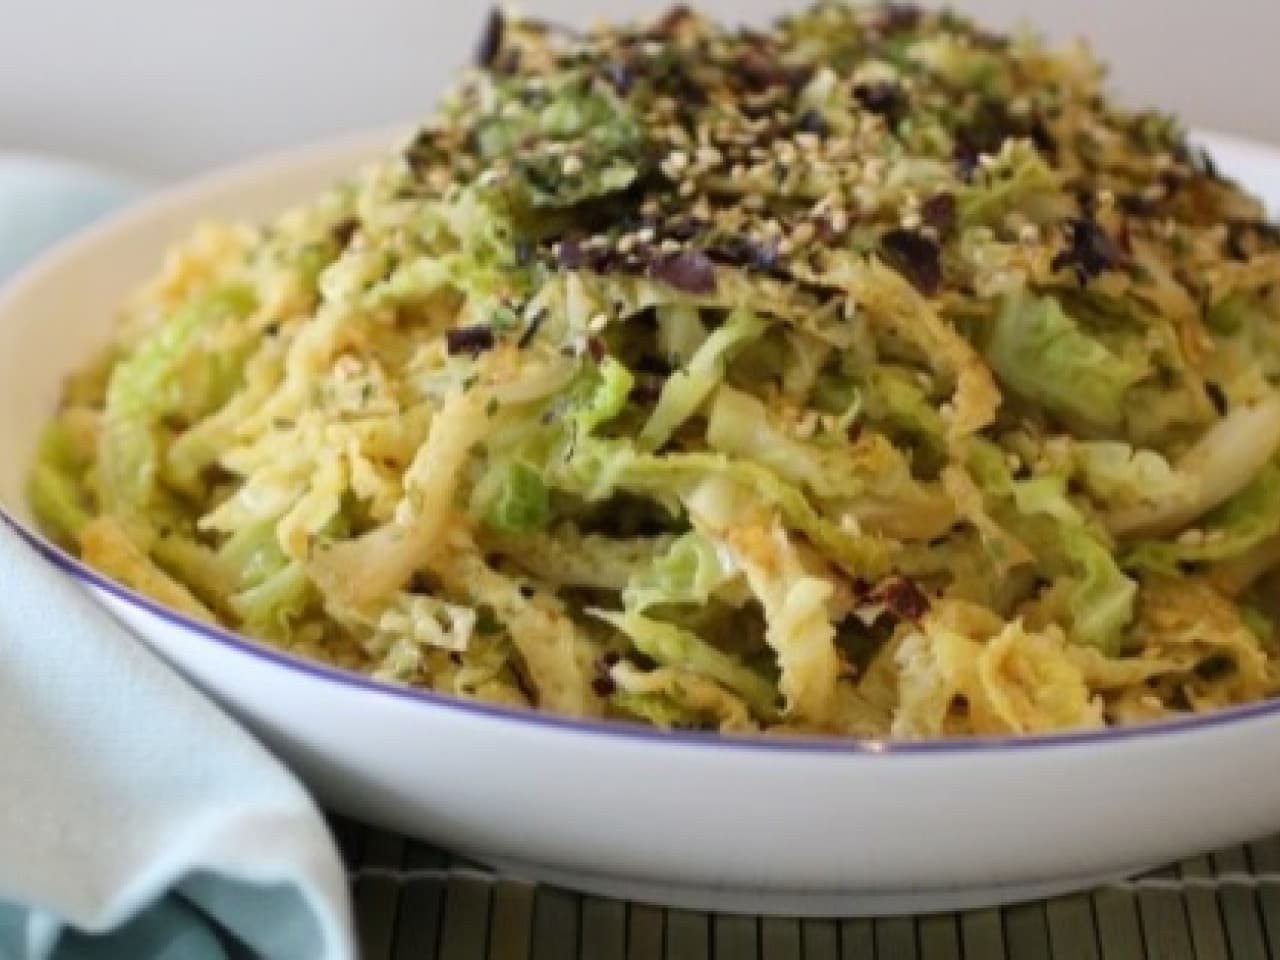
left=0, top=0, right=1280, bottom=175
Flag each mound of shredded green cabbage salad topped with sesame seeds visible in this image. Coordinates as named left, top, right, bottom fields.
left=31, top=3, right=1280, bottom=737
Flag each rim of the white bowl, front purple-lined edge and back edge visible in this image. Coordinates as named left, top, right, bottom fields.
left=0, top=124, right=1280, bottom=758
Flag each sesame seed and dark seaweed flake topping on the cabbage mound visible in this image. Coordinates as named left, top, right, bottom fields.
left=406, top=3, right=1276, bottom=327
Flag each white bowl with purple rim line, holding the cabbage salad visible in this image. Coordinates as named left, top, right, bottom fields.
left=0, top=132, right=1280, bottom=915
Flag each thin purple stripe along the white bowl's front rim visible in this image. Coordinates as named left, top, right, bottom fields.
left=0, top=506, right=1280, bottom=756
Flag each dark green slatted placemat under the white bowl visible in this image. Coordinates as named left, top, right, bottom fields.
left=333, top=818, right=1280, bottom=960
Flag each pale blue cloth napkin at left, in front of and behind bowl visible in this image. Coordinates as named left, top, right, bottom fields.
left=0, top=157, right=355, bottom=960
